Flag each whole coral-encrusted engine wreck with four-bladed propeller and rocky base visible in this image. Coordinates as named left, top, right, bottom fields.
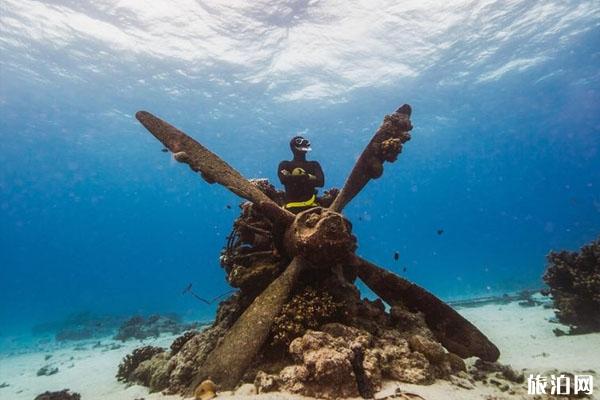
left=136, top=105, right=499, bottom=398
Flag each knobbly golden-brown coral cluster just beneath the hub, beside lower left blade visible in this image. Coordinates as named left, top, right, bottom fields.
left=272, top=286, right=341, bottom=347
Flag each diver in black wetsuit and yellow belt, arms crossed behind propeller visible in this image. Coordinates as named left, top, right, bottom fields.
left=277, top=136, right=325, bottom=214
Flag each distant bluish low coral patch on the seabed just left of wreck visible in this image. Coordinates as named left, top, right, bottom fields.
left=115, top=315, right=197, bottom=342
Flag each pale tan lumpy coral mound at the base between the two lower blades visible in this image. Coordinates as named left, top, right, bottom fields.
left=255, top=323, right=465, bottom=399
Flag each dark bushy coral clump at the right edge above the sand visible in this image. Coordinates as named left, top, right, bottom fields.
left=544, top=238, right=600, bottom=333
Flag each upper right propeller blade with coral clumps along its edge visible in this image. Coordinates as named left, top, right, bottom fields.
left=329, top=104, right=412, bottom=212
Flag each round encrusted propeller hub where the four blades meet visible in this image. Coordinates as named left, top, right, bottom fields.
left=285, top=207, right=356, bottom=267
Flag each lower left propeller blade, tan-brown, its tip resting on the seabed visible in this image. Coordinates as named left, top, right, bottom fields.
left=188, top=256, right=309, bottom=393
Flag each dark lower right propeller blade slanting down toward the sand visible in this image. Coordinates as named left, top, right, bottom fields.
left=354, top=257, right=500, bottom=362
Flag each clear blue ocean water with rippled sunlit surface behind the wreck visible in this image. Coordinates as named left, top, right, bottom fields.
left=0, top=0, right=600, bottom=335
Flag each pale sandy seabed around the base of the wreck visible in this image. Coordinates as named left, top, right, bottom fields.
left=0, top=302, right=600, bottom=400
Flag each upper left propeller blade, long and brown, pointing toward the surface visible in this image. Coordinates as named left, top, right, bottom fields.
left=135, top=111, right=294, bottom=221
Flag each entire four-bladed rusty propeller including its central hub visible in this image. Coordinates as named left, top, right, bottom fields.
left=136, top=104, right=500, bottom=393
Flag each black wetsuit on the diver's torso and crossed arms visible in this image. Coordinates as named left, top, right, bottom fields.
left=277, top=152, right=325, bottom=206
